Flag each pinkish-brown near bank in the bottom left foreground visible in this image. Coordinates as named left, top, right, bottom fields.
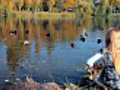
left=0, top=76, right=63, bottom=90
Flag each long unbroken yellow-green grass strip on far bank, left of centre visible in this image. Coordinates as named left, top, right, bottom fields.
left=8, top=12, right=76, bottom=19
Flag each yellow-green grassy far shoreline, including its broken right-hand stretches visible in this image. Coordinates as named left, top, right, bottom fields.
left=0, top=11, right=120, bottom=19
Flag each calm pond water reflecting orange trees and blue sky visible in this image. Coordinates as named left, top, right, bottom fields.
left=0, top=17, right=118, bottom=83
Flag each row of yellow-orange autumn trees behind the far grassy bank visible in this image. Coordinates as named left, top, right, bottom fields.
left=0, top=0, right=115, bottom=15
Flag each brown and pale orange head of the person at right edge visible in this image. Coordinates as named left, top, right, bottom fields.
left=105, top=28, right=120, bottom=76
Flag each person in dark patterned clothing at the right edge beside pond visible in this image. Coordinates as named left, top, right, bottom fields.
left=87, top=28, right=120, bottom=90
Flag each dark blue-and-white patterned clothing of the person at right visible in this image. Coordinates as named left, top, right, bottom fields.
left=98, top=49, right=120, bottom=90
